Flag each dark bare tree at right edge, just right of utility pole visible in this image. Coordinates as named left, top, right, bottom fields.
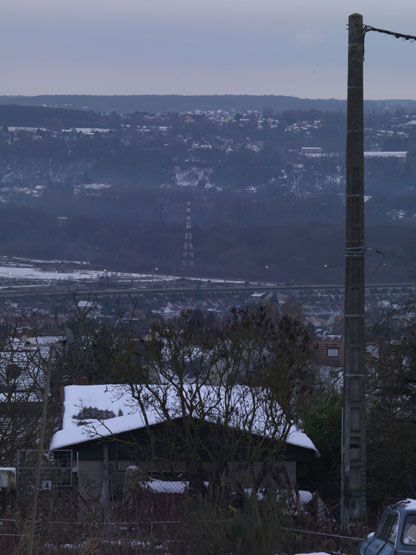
left=367, top=312, right=416, bottom=506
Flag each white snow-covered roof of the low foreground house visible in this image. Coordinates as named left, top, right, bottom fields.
left=50, top=384, right=317, bottom=452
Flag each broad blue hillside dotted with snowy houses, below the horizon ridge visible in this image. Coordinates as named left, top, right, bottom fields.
left=0, top=105, right=416, bottom=283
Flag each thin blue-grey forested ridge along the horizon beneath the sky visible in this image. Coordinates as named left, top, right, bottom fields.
left=0, top=95, right=416, bottom=113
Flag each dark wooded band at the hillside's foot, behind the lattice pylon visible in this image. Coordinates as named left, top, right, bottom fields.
left=0, top=196, right=416, bottom=283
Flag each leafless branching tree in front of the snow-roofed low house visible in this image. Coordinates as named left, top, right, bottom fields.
left=114, top=308, right=308, bottom=498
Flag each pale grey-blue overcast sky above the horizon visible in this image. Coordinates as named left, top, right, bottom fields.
left=0, top=0, right=416, bottom=98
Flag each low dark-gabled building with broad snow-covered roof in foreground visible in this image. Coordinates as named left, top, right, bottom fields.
left=51, top=384, right=317, bottom=504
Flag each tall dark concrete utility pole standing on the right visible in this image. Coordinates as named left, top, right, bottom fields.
left=341, top=14, right=366, bottom=531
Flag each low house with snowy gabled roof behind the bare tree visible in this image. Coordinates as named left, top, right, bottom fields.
left=50, top=384, right=317, bottom=506
